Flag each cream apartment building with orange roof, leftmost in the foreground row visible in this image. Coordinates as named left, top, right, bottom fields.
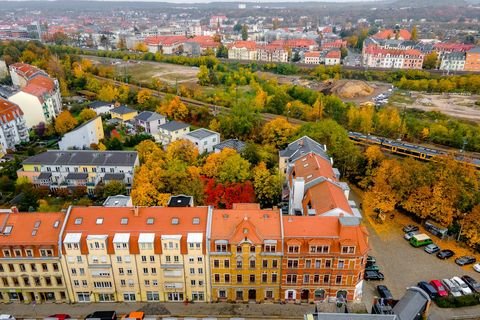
left=0, top=208, right=69, bottom=303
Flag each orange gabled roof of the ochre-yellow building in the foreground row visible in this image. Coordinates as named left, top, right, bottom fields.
left=211, top=204, right=281, bottom=245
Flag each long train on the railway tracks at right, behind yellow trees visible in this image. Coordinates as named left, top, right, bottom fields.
left=348, top=131, right=480, bottom=170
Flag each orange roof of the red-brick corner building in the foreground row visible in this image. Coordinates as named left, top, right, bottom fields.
left=282, top=216, right=369, bottom=254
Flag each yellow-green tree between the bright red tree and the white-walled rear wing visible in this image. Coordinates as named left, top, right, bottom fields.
left=253, top=162, right=282, bottom=208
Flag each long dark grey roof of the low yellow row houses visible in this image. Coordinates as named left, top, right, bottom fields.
left=22, top=150, right=138, bottom=166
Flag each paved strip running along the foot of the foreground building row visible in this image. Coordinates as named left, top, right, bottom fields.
left=0, top=302, right=315, bottom=319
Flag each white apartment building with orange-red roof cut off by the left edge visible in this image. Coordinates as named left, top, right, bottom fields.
left=0, top=98, right=29, bottom=154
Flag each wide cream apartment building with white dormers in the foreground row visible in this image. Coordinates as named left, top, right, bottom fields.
left=62, top=207, right=210, bottom=302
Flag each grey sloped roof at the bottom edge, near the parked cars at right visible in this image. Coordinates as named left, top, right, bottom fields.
left=393, top=287, right=430, bottom=320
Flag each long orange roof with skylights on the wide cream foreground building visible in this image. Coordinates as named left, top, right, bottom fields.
left=64, top=207, right=208, bottom=253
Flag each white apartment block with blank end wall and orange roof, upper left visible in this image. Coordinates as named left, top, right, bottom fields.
left=8, top=63, right=62, bottom=128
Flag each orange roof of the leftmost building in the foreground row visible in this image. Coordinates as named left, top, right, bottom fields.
left=0, top=212, right=65, bottom=247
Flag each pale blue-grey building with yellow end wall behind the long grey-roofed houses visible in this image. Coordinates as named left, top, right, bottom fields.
left=58, top=116, right=104, bottom=150
